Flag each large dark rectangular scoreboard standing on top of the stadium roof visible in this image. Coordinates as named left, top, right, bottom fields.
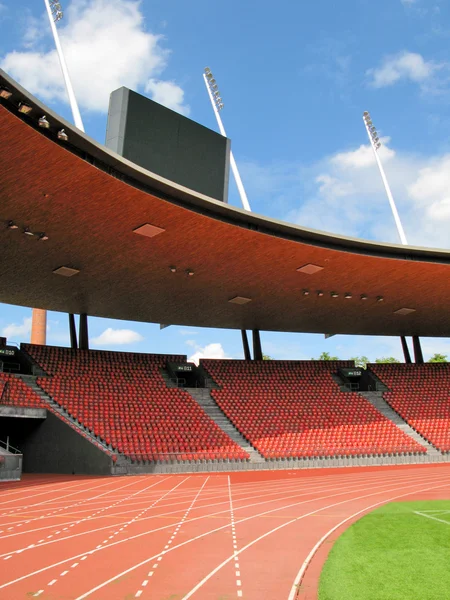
left=106, top=87, right=231, bottom=202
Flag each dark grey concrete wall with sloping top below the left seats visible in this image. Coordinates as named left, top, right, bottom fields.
left=0, top=412, right=112, bottom=475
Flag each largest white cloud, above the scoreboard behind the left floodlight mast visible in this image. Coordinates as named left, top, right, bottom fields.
left=0, top=0, right=188, bottom=112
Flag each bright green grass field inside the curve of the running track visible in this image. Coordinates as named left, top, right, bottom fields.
left=319, top=501, right=450, bottom=600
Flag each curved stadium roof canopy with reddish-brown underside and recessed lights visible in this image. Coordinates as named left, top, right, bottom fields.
left=0, top=71, right=450, bottom=336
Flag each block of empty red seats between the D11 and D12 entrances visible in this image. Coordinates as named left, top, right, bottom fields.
left=202, top=359, right=426, bottom=459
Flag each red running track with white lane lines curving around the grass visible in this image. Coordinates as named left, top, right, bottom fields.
left=0, top=465, right=450, bottom=600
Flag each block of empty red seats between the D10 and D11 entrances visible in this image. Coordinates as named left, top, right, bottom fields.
left=22, top=345, right=248, bottom=461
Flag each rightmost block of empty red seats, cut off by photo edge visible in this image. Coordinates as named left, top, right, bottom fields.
left=369, top=363, right=450, bottom=452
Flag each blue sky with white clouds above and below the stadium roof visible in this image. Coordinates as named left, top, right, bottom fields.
left=0, top=0, right=450, bottom=359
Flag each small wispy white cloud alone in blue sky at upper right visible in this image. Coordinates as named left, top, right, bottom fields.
left=367, top=51, right=444, bottom=88
